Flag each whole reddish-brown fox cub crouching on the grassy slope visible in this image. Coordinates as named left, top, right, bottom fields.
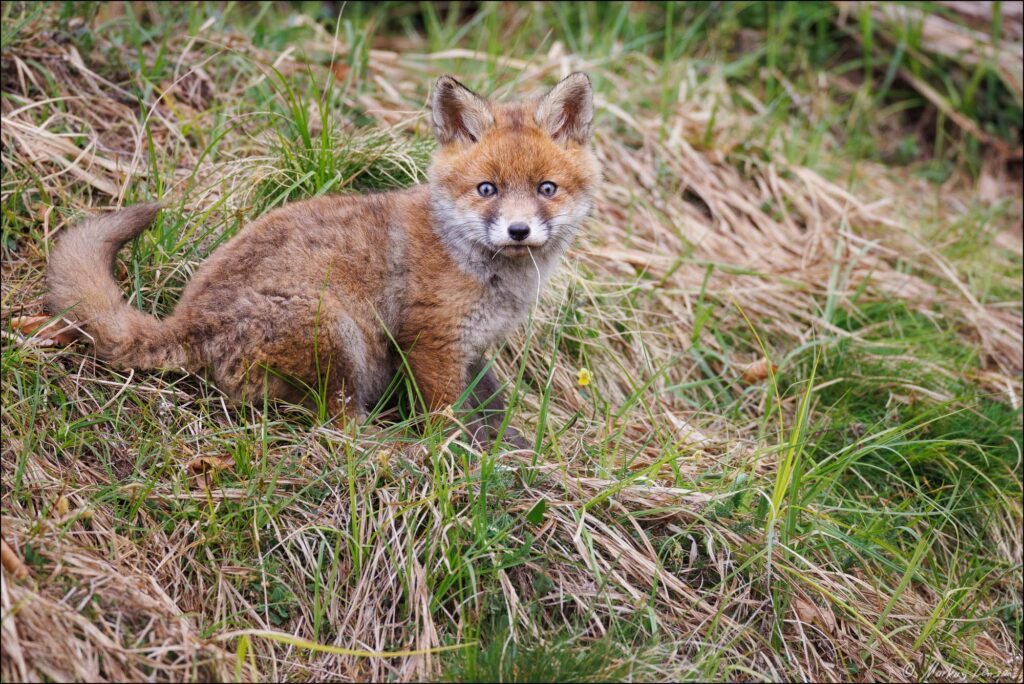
left=46, top=73, right=600, bottom=441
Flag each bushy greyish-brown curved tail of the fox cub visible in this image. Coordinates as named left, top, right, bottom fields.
left=46, top=204, right=185, bottom=369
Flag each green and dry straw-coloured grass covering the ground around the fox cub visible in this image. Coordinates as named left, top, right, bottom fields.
left=0, top=3, right=1024, bottom=681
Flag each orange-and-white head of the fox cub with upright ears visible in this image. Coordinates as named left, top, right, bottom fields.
left=429, top=73, right=600, bottom=261
